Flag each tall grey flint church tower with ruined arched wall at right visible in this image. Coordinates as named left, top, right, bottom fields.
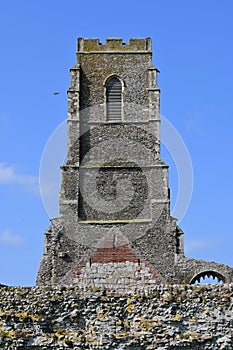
left=37, top=38, right=233, bottom=288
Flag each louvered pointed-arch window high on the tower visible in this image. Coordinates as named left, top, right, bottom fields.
left=106, top=78, right=122, bottom=121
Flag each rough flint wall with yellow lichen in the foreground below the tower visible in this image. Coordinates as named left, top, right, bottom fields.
left=0, top=284, right=233, bottom=350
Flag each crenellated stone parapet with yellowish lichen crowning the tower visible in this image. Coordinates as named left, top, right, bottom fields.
left=78, top=38, right=152, bottom=53
